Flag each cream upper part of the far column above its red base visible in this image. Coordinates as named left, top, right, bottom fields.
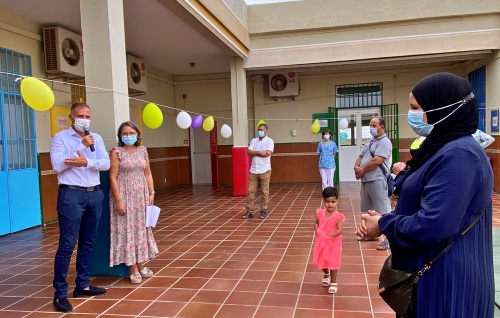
left=231, top=57, right=248, bottom=147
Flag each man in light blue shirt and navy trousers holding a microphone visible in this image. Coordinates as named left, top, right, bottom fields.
left=50, top=103, right=110, bottom=312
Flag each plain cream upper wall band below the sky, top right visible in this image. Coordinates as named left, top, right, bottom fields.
left=248, top=0, right=500, bottom=34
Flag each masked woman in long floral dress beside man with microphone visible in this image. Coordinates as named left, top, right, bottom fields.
left=109, top=121, right=158, bottom=284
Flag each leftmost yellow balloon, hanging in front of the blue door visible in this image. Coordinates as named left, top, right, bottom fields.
left=21, top=77, right=54, bottom=111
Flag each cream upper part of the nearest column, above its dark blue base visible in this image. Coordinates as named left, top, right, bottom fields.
left=80, top=0, right=130, bottom=149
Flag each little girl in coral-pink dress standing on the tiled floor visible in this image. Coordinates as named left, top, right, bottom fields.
left=313, top=187, right=345, bottom=294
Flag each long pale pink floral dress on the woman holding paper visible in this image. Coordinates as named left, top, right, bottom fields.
left=109, top=146, right=158, bottom=267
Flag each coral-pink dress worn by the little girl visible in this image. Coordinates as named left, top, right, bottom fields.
left=313, top=209, right=345, bottom=270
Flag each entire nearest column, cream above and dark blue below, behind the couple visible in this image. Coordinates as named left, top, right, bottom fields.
left=80, top=0, right=130, bottom=276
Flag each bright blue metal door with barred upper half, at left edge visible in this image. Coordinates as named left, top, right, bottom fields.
left=0, top=48, right=41, bottom=235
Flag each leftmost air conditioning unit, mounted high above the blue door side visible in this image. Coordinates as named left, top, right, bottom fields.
left=43, top=26, right=85, bottom=79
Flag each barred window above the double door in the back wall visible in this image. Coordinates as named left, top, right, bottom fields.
left=335, top=83, right=382, bottom=108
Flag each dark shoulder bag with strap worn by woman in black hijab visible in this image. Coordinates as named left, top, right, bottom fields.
left=377, top=210, right=484, bottom=318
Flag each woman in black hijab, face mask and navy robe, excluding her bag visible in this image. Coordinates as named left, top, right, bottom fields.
left=357, top=73, right=494, bottom=318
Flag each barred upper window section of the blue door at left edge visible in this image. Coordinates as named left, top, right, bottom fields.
left=0, top=48, right=37, bottom=171
